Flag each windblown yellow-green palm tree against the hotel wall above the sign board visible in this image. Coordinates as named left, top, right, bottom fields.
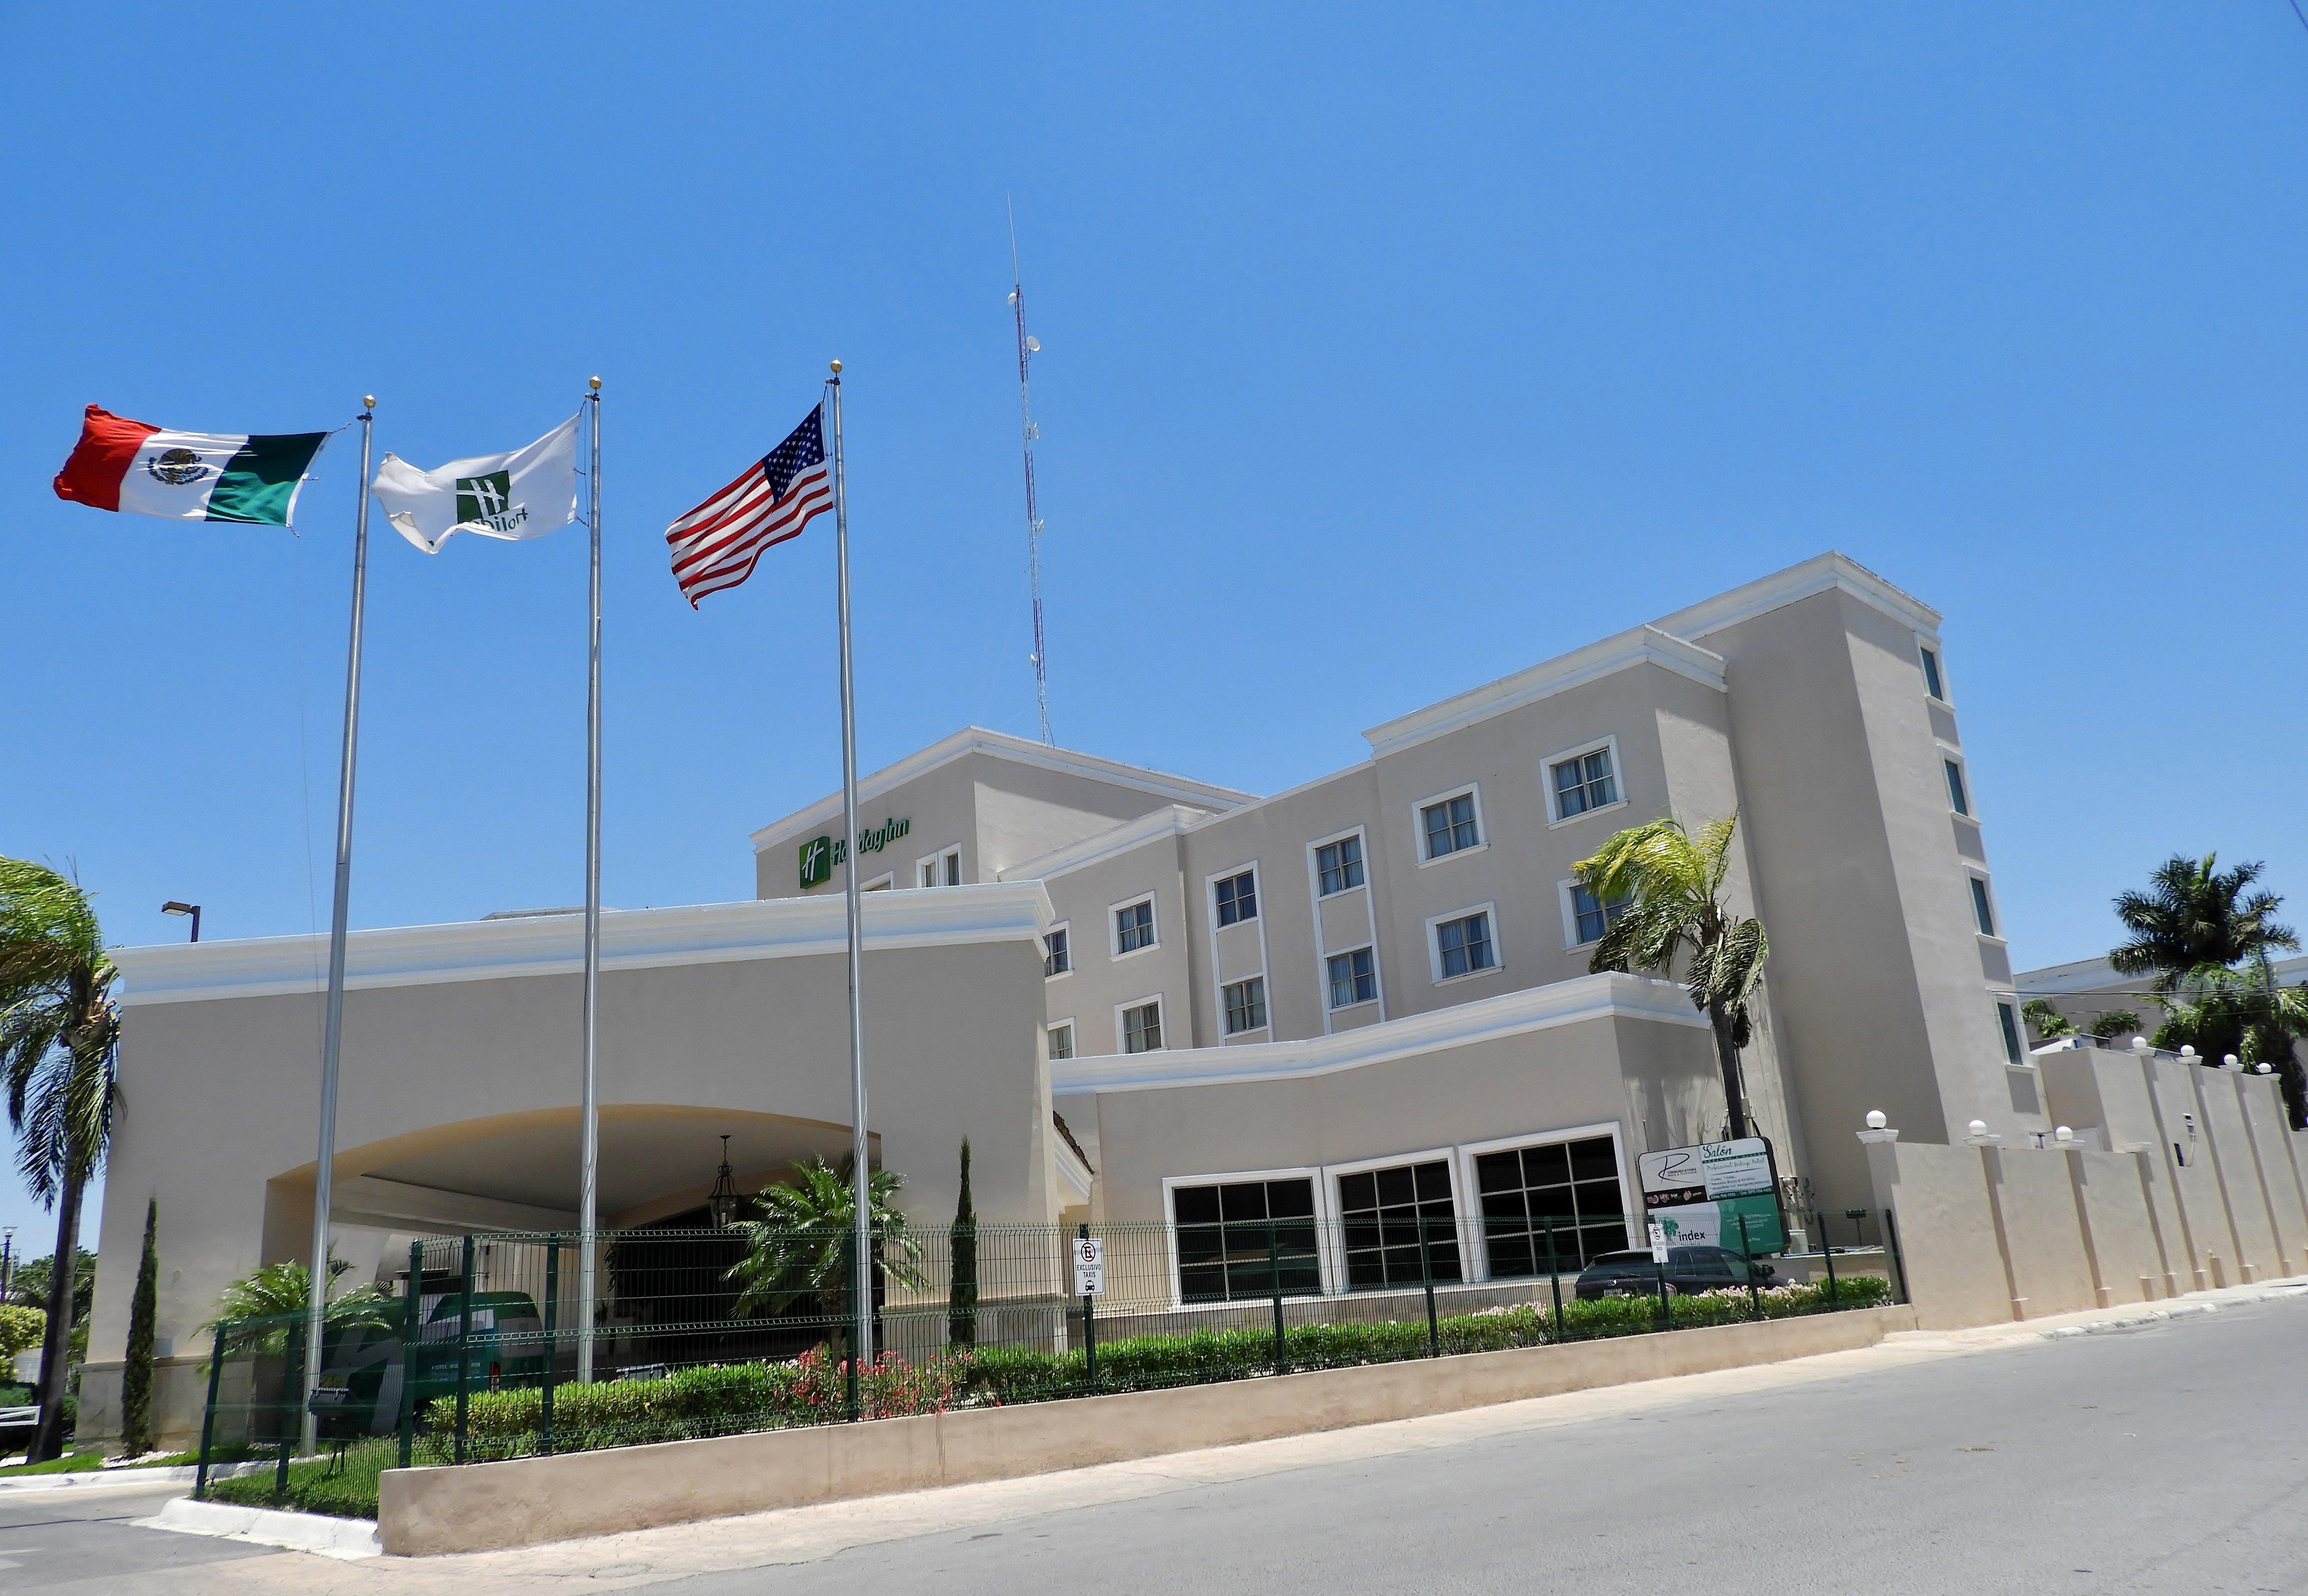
left=1572, top=814, right=1770, bottom=1139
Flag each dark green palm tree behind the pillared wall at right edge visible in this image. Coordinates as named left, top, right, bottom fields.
left=2107, top=853, right=2308, bottom=1128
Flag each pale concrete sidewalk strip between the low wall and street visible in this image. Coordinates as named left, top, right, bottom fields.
left=81, top=1278, right=2308, bottom=1596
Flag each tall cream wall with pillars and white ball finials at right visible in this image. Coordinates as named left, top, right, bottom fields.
left=1862, top=1049, right=2308, bottom=1328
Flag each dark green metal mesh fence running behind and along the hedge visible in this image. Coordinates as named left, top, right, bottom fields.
left=196, top=1209, right=1906, bottom=1494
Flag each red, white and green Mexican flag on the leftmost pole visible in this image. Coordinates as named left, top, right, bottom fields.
left=55, top=406, right=328, bottom=526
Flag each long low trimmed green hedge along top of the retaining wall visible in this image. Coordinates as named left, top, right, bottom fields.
left=415, top=1275, right=1890, bottom=1478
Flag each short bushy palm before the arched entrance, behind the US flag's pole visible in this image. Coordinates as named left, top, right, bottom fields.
left=727, top=1153, right=926, bottom=1342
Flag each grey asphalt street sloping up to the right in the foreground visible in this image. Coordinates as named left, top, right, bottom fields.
left=669, top=1291, right=2308, bottom=1596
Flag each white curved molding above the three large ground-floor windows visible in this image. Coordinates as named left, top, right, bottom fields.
left=1050, top=971, right=1708, bottom=1093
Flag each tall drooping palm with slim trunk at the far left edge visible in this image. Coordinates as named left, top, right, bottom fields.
left=0, top=858, right=120, bottom=1462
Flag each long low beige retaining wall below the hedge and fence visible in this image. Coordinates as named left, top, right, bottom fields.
left=378, top=1308, right=1914, bottom=1557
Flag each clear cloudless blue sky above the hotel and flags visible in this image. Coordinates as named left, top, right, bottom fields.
left=0, top=0, right=2308, bottom=1250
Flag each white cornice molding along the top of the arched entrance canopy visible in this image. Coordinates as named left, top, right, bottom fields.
left=113, top=881, right=1055, bottom=1008
